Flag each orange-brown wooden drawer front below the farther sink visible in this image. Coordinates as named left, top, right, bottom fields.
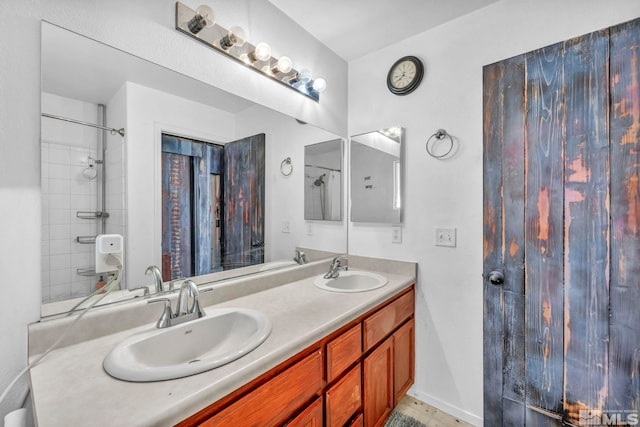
left=364, top=289, right=414, bottom=351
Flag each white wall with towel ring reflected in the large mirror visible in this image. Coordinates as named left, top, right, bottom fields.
left=236, top=106, right=347, bottom=261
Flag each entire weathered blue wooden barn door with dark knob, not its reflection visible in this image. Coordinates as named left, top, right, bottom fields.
left=484, top=20, right=640, bottom=427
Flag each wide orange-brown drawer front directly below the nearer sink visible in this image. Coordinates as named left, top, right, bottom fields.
left=202, top=350, right=323, bottom=427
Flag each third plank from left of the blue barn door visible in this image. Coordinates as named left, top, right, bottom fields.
left=525, top=43, right=564, bottom=413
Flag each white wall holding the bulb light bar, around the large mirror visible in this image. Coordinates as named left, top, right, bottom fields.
left=0, top=0, right=347, bottom=419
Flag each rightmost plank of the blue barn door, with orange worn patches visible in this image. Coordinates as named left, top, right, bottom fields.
left=608, top=16, right=640, bottom=411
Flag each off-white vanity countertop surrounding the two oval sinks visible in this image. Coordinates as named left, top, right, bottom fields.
left=30, top=273, right=415, bottom=427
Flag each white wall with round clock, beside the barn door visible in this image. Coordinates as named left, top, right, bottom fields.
left=349, top=0, right=640, bottom=424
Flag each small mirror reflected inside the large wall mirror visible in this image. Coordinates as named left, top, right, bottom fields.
left=304, top=139, right=342, bottom=221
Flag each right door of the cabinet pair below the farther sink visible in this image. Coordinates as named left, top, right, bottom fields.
left=393, top=319, right=415, bottom=405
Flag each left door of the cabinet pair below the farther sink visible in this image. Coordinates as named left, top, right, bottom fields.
left=364, top=337, right=394, bottom=427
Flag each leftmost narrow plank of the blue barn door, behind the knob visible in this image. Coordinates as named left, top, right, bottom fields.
left=483, top=60, right=504, bottom=427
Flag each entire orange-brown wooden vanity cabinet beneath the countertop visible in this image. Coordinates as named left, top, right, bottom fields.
left=178, top=286, right=415, bottom=427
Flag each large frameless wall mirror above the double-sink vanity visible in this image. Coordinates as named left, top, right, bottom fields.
left=41, top=22, right=347, bottom=315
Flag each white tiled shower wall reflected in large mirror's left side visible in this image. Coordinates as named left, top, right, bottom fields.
left=41, top=94, right=101, bottom=303
